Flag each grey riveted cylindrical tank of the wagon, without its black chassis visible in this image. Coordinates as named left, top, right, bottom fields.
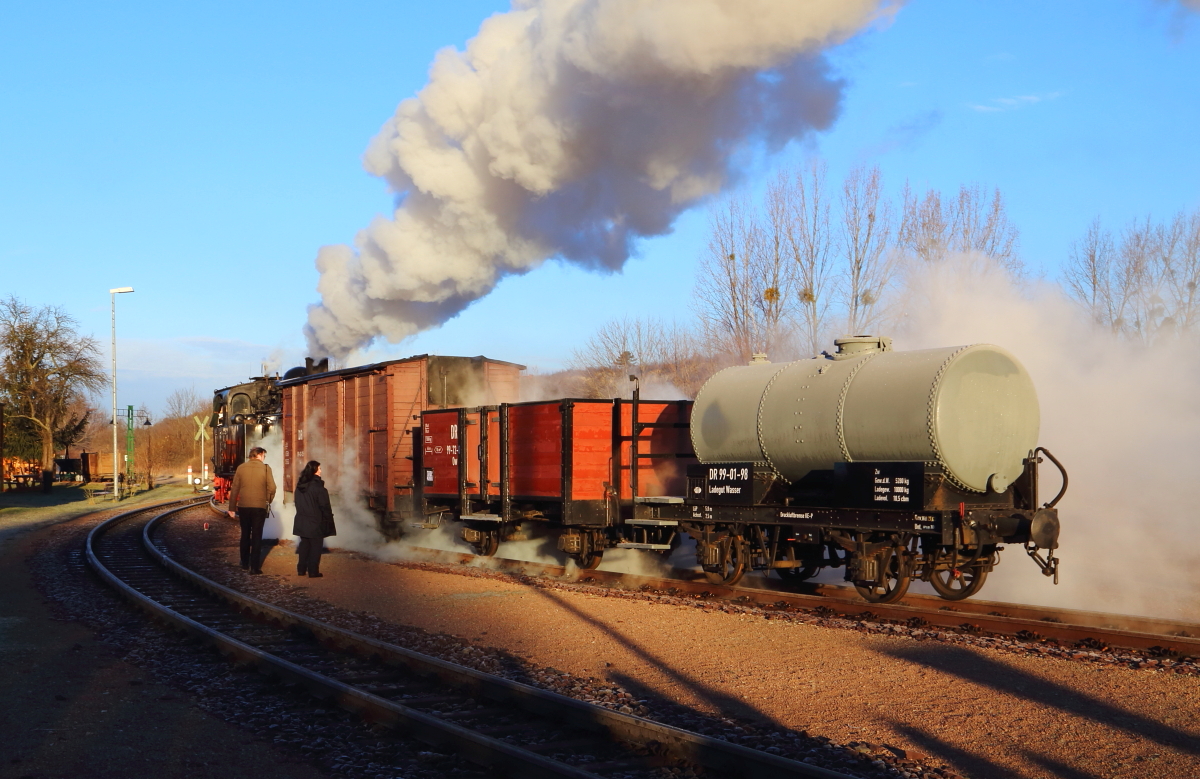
left=691, top=336, right=1040, bottom=492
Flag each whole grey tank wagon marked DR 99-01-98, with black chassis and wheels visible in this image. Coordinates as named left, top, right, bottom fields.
left=681, top=336, right=1067, bottom=603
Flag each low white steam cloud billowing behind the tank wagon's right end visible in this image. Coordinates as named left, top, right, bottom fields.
left=892, top=257, right=1200, bottom=621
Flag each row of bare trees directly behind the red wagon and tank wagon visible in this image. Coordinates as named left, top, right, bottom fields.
left=571, top=160, right=1024, bottom=397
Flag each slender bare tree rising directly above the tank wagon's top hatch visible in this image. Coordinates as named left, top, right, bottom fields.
left=838, top=166, right=895, bottom=334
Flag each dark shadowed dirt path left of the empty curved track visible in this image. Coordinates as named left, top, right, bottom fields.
left=0, top=501, right=326, bottom=779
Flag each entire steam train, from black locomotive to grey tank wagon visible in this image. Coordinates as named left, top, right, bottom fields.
left=212, top=336, right=1067, bottom=603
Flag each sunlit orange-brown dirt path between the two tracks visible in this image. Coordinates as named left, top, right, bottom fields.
left=220, top=523, right=1200, bottom=779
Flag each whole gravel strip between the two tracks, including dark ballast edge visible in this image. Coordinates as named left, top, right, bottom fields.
left=150, top=511, right=1200, bottom=778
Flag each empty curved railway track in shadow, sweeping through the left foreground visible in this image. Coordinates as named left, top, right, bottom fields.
left=85, top=501, right=848, bottom=779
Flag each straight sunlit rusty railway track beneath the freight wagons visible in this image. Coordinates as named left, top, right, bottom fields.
left=398, top=549, right=1200, bottom=658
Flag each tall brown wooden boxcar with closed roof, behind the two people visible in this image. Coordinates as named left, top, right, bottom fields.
left=278, top=354, right=524, bottom=522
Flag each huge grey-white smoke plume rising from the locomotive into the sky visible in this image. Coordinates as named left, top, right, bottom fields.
left=306, top=0, right=899, bottom=356
